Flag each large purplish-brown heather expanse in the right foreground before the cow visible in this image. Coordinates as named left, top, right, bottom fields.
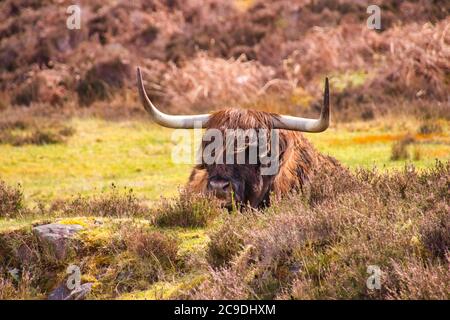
left=192, top=163, right=450, bottom=299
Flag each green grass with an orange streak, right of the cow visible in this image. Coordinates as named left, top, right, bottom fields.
left=307, top=119, right=450, bottom=170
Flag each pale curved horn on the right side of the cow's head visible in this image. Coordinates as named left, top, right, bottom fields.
left=274, top=78, right=330, bottom=132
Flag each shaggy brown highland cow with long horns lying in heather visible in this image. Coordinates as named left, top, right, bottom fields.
left=137, top=68, right=341, bottom=207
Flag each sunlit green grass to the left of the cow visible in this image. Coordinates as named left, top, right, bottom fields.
left=0, top=119, right=189, bottom=204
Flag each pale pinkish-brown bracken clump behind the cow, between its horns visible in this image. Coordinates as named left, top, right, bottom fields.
left=156, top=54, right=273, bottom=112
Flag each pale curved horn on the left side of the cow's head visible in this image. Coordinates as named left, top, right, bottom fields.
left=137, top=67, right=209, bottom=129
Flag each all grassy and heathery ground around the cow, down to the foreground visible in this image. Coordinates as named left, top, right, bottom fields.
left=0, top=118, right=450, bottom=299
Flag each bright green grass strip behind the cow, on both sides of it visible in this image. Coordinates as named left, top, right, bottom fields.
left=0, top=119, right=450, bottom=201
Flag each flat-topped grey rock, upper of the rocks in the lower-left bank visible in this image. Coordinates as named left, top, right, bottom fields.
left=33, top=223, right=83, bottom=260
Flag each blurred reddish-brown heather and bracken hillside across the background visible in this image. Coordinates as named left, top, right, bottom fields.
left=0, top=0, right=450, bottom=119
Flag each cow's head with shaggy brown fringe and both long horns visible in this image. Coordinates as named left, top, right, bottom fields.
left=137, top=68, right=330, bottom=207
